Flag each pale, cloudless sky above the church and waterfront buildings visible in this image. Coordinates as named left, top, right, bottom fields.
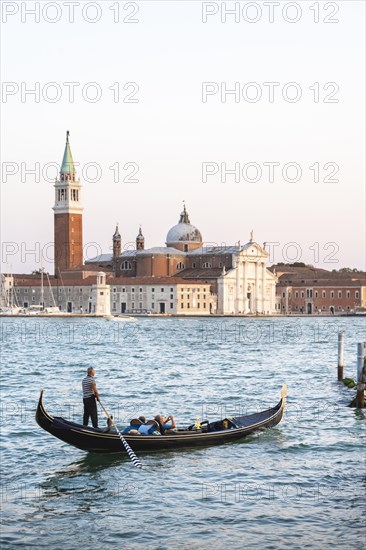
left=1, top=0, right=365, bottom=273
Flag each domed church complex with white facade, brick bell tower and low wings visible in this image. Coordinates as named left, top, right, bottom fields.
left=9, top=133, right=276, bottom=315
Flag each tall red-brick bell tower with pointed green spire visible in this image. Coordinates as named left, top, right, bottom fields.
left=53, top=131, right=83, bottom=277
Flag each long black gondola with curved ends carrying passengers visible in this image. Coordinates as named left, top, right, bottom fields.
left=36, top=385, right=286, bottom=453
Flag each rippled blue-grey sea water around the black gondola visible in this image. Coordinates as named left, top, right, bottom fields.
left=1, top=317, right=366, bottom=550
